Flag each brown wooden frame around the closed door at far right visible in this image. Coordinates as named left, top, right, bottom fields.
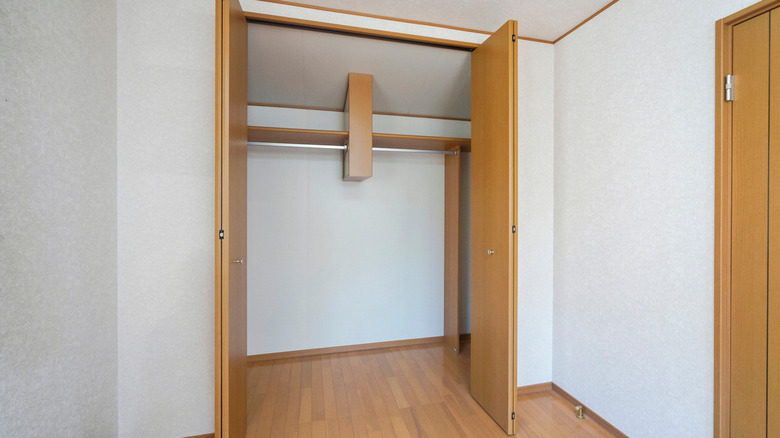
left=713, top=0, right=780, bottom=438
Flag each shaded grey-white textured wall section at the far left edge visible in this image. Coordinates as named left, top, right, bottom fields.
left=0, top=0, right=117, bottom=437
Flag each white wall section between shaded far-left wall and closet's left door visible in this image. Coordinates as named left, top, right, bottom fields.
left=116, top=0, right=215, bottom=437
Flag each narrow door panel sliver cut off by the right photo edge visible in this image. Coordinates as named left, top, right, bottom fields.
left=767, top=9, right=780, bottom=438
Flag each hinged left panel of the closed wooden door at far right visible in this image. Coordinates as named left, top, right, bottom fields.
left=731, top=14, right=768, bottom=437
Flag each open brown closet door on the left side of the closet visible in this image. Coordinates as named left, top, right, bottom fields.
left=214, top=0, right=247, bottom=438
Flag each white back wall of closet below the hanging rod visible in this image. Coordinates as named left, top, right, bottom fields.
left=247, top=148, right=444, bottom=355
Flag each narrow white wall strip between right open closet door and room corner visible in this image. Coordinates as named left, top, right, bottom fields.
left=517, top=40, right=555, bottom=386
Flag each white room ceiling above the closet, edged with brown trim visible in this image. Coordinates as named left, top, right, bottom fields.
left=284, top=0, right=609, bottom=41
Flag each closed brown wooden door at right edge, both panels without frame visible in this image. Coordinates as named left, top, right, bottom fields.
left=730, top=10, right=780, bottom=438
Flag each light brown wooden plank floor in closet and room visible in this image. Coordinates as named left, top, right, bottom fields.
left=247, top=344, right=610, bottom=438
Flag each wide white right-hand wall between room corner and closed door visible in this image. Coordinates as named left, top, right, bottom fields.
left=553, top=0, right=754, bottom=437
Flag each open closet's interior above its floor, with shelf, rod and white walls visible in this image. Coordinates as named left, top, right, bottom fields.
left=247, top=22, right=471, bottom=362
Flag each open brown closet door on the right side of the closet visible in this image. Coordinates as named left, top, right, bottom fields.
left=471, top=21, right=517, bottom=435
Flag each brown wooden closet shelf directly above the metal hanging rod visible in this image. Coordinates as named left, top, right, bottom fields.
left=248, top=126, right=471, bottom=152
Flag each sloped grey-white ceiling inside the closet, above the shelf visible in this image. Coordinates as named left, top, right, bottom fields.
left=247, top=23, right=471, bottom=118
